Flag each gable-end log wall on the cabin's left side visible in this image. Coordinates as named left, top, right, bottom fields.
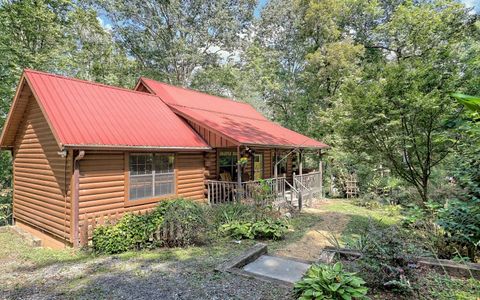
left=13, top=95, right=73, bottom=241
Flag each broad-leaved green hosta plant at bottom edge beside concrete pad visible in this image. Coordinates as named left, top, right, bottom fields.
left=294, top=262, right=368, bottom=300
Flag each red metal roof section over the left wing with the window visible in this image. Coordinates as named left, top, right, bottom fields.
left=20, top=70, right=209, bottom=149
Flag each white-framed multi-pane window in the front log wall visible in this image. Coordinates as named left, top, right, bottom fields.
left=129, top=153, right=175, bottom=200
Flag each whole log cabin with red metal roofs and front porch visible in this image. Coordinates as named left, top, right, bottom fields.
left=0, top=69, right=328, bottom=248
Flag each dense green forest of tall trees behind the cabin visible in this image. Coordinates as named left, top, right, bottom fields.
left=0, top=0, right=480, bottom=237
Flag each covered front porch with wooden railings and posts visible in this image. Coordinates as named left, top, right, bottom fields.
left=206, top=147, right=323, bottom=209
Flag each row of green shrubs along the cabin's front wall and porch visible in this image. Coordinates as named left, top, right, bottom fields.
left=92, top=198, right=288, bottom=254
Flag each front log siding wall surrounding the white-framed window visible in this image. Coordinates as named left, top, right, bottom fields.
left=79, top=151, right=205, bottom=223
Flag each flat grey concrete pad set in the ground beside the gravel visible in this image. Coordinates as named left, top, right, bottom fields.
left=243, top=255, right=310, bottom=283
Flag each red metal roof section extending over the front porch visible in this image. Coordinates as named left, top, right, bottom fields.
left=137, top=78, right=328, bottom=148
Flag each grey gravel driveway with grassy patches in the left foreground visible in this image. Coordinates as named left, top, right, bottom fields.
left=0, top=237, right=291, bottom=299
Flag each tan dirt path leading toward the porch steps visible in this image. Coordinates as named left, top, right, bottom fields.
left=275, top=200, right=350, bottom=261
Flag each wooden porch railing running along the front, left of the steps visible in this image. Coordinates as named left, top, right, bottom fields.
left=207, top=177, right=286, bottom=204
